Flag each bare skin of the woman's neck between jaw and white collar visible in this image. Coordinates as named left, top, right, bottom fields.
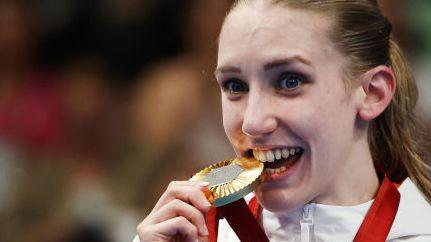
left=315, top=137, right=379, bottom=206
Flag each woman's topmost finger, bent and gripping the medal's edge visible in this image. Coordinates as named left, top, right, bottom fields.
left=152, top=181, right=211, bottom=213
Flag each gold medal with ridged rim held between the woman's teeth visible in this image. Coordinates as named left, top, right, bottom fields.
left=190, top=158, right=263, bottom=207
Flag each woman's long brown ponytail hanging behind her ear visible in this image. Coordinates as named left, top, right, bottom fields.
left=368, top=38, right=431, bottom=202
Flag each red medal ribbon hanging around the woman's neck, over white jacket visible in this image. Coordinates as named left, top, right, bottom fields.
left=206, top=176, right=400, bottom=242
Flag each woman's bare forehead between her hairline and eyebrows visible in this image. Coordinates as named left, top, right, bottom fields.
left=218, top=1, right=336, bottom=67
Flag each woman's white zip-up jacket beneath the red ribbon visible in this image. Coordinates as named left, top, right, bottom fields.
left=218, top=179, right=431, bottom=242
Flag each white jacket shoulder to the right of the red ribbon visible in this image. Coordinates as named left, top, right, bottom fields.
left=388, top=178, right=431, bottom=241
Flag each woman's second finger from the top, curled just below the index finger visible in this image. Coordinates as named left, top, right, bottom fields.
left=147, top=199, right=208, bottom=236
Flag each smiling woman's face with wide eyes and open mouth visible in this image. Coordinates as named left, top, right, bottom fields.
left=216, top=2, right=364, bottom=211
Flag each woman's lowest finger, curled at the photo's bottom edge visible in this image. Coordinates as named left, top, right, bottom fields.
left=138, top=217, right=198, bottom=242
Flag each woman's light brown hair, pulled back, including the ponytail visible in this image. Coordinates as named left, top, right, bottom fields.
left=233, top=0, right=431, bottom=202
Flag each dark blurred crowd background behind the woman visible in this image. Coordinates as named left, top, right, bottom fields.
left=0, top=0, right=431, bottom=242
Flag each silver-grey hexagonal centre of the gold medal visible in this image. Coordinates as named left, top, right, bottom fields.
left=203, top=163, right=243, bottom=186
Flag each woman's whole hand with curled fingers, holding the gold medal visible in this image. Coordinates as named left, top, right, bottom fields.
left=137, top=181, right=211, bottom=242
